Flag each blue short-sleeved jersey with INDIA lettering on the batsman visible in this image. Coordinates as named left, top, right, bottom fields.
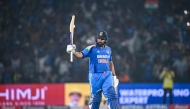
left=82, top=45, right=112, bottom=73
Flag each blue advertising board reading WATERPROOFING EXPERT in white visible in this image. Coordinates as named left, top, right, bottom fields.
left=118, top=84, right=190, bottom=105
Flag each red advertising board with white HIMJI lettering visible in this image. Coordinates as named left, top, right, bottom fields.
left=0, top=84, right=64, bottom=106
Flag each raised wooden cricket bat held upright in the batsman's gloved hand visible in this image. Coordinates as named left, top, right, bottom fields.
left=70, top=15, right=75, bottom=62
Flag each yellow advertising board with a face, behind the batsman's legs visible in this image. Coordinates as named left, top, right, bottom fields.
left=65, top=83, right=106, bottom=106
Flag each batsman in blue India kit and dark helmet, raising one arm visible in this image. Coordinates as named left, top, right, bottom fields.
left=67, top=30, right=119, bottom=109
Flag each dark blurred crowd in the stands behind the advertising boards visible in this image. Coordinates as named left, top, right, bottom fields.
left=0, top=0, right=190, bottom=83
